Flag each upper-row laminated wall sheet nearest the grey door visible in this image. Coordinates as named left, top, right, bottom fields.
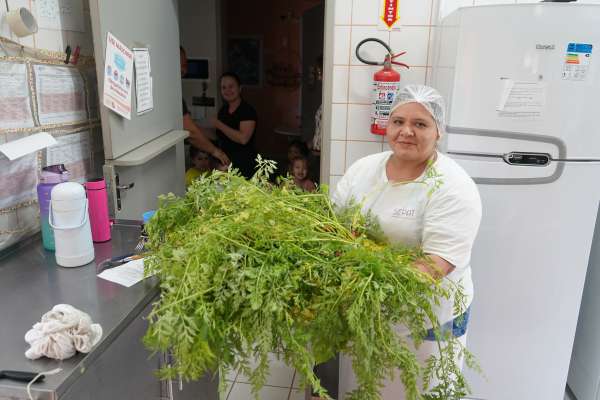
left=33, top=65, right=87, bottom=125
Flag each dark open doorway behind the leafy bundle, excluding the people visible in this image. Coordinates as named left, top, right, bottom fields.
left=179, top=0, right=325, bottom=183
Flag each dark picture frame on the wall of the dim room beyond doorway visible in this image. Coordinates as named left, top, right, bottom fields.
left=227, top=36, right=263, bottom=87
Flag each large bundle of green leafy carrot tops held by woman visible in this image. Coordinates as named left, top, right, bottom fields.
left=145, top=161, right=471, bottom=400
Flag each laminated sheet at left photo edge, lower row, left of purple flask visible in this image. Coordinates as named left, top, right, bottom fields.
left=0, top=153, right=38, bottom=209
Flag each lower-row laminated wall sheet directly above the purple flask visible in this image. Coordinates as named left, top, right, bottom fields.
left=46, top=131, right=91, bottom=182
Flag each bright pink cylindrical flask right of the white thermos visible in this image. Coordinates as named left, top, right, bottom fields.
left=85, top=178, right=110, bottom=242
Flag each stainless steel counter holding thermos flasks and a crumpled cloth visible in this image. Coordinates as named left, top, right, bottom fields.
left=0, top=223, right=159, bottom=399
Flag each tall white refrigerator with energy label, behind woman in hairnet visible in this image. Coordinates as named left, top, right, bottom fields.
left=432, top=3, right=600, bottom=400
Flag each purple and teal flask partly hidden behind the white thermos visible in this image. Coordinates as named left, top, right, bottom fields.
left=37, top=164, right=69, bottom=251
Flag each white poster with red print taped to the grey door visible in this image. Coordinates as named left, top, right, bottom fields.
left=102, top=32, right=133, bottom=119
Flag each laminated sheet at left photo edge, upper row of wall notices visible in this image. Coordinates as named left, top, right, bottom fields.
left=0, top=61, right=34, bottom=129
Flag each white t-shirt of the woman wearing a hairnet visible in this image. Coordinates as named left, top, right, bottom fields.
left=332, top=151, right=481, bottom=323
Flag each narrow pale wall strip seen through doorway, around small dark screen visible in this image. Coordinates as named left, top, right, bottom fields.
left=179, top=0, right=221, bottom=121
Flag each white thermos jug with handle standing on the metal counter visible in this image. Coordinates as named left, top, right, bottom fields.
left=50, top=182, right=94, bottom=267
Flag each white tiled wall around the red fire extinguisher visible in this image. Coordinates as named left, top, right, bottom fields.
left=329, top=0, right=600, bottom=189
